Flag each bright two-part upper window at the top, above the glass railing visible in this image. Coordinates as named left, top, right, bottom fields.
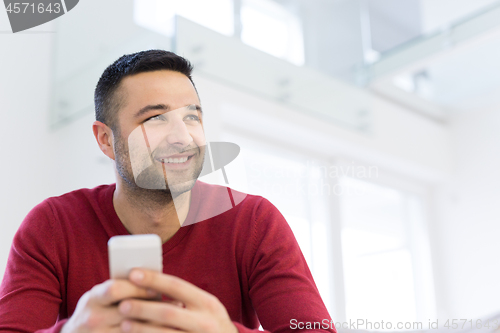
left=134, top=0, right=304, bottom=66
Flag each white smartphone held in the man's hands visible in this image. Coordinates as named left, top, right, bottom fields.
left=108, top=234, right=163, bottom=279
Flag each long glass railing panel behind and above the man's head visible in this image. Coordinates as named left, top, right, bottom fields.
left=50, top=1, right=370, bottom=132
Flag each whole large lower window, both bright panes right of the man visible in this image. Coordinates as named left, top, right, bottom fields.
left=221, top=128, right=435, bottom=320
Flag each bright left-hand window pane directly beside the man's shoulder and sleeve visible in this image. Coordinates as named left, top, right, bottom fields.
left=222, top=132, right=333, bottom=316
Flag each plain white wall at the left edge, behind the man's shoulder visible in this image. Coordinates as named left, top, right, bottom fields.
left=0, top=14, right=113, bottom=276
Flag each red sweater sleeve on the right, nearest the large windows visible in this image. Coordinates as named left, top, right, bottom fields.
left=242, top=199, right=336, bottom=333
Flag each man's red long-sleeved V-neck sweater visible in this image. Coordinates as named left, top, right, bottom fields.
left=0, top=181, right=335, bottom=332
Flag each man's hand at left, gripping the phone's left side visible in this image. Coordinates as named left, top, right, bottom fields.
left=61, top=280, right=158, bottom=333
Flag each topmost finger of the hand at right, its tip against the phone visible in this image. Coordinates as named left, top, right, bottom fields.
left=129, top=269, right=215, bottom=308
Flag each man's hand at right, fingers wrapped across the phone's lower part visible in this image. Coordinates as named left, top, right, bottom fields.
left=119, top=269, right=238, bottom=333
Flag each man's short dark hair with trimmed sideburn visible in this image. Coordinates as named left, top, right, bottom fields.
left=94, top=50, right=198, bottom=131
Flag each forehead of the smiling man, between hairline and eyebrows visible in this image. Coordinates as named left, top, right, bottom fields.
left=118, top=70, right=200, bottom=111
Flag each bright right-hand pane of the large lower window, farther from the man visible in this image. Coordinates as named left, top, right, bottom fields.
left=340, top=177, right=433, bottom=329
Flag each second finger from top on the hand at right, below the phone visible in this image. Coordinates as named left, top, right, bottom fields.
left=118, top=300, right=196, bottom=331
